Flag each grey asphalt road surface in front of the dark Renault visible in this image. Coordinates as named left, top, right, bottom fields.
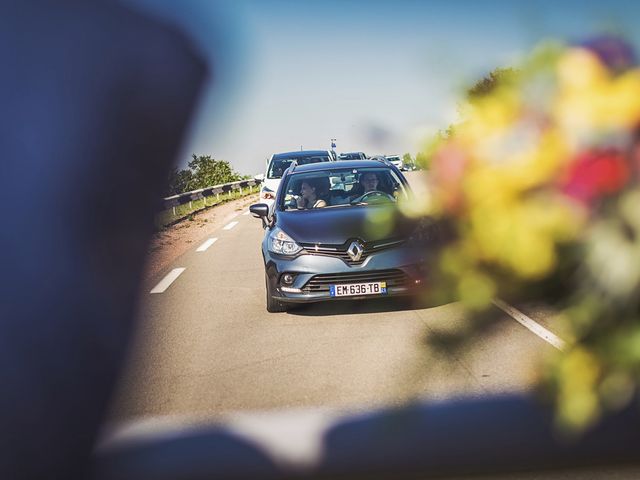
left=113, top=174, right=554, bottom=422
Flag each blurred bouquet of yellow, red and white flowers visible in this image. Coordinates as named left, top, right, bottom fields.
left=428, top=37, right=640, bottom=428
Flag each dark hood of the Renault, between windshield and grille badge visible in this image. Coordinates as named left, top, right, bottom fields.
left=276, top=206, right=417, bottom=245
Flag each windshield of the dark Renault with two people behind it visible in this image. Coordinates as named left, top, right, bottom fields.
left=278, top=168, right=408, bottom=211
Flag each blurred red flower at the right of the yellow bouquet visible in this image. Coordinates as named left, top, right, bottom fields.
left=562, top=149, right=630, bottom=203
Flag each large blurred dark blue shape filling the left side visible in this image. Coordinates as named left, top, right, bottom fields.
left=0, top=0, right=207, bottom=479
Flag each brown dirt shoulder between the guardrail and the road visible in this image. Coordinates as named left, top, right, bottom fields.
left=144, top=193, right=258, bottom=280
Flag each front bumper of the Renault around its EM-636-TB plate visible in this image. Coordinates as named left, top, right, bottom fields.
left=263, top=246, right=427, bottom=303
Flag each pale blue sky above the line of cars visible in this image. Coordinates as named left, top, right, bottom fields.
left=124, top=0, right=640, bottom=175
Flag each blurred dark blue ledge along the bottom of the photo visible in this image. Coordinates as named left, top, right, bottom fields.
left=94, top=395, right=640, bottom=480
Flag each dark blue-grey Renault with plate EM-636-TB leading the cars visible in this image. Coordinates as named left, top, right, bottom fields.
left=251, top=160, right=425, bottom=312
